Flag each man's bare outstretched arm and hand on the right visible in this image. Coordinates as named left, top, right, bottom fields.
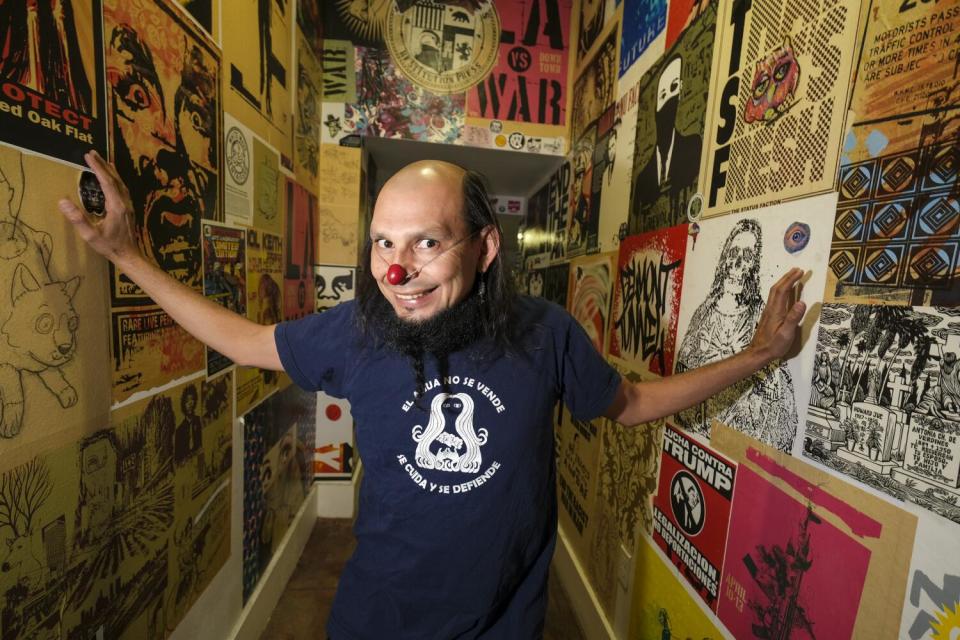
left=605, top=268, right=806, bottom=425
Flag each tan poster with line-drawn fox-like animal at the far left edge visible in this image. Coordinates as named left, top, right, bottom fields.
left=0, top=147, right=110, bottom=466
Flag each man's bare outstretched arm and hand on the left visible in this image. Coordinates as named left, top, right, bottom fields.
left=59, top=151, right=283, bottom=371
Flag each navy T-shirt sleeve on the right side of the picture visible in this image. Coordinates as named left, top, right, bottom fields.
left=559, top=313, right=620, bottom=421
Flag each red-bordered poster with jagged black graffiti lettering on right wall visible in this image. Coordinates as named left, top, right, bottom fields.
left=610, top=225, right=688, bottom=376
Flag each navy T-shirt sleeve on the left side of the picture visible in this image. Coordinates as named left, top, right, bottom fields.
left=273, top=303, right=355, bottom=398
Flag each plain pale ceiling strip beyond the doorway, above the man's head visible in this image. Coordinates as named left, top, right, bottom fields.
left=362, top=136, right=563, bottom=197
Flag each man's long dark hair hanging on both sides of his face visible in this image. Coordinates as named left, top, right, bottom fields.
left=356, top=171, right=516, bottom=347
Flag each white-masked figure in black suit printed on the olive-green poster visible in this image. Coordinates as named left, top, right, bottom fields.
left=629, top=57, right=702, bottom=234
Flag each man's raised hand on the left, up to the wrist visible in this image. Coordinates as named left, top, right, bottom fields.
left=59, top=151, right=142, bottom=266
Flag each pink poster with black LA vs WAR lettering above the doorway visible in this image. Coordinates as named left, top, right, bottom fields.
left=467, top=0, right=572, bottom=137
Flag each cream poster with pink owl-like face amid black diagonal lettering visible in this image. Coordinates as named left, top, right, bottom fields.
left=700, top=0, right=861, bottom=216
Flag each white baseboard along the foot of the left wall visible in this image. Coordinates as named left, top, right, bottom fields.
left=229, top=483, right=317, bottom=640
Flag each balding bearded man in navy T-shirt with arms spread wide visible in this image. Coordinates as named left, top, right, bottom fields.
left=60, top=154, right=804, bottom=640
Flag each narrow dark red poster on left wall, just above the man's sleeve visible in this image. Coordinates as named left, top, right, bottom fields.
left=283, top=179, right=317, bottom=320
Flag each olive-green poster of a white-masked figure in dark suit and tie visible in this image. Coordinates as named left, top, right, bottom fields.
left=627, top=3, right=717, bottom=234
